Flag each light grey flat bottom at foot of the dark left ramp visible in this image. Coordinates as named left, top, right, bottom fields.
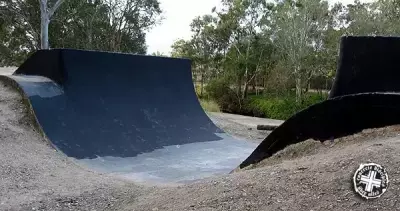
left=78, top=134, right=257, bottom=183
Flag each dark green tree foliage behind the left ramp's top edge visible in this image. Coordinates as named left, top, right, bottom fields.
left=0, top=0, right=162, bottom=66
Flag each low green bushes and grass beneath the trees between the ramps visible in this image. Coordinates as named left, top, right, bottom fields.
left=200, top=79, right=328, bottom=120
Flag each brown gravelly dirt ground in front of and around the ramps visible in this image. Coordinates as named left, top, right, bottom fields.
left=0, top=78, right=400, bottom=211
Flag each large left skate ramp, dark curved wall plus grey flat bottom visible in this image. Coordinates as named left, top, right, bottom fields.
left=2, top=49, right=256, bottom=182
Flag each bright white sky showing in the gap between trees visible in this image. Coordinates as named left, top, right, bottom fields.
left=146, top=0, right=374, bottom=54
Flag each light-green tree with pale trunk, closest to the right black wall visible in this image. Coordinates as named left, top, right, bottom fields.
left=273, top=0, right=328, bottom=103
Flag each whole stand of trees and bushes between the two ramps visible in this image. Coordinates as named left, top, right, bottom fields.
left=172, top=0, right=400, bottom=119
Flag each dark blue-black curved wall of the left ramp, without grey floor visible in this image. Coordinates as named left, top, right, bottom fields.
left=8, top=49, right=253, bottom=160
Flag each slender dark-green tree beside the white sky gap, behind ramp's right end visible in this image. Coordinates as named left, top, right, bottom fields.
left=214, top=0, right=272, bottom=99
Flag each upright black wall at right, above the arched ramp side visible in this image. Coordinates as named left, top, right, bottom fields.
left=330, top=36, right=400, bottom=98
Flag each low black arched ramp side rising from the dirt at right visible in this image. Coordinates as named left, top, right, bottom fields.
left=236, top=92, right=400, bottom=170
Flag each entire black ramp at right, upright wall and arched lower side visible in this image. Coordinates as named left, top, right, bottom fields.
left=239, top=36, right=400, bottom=168
